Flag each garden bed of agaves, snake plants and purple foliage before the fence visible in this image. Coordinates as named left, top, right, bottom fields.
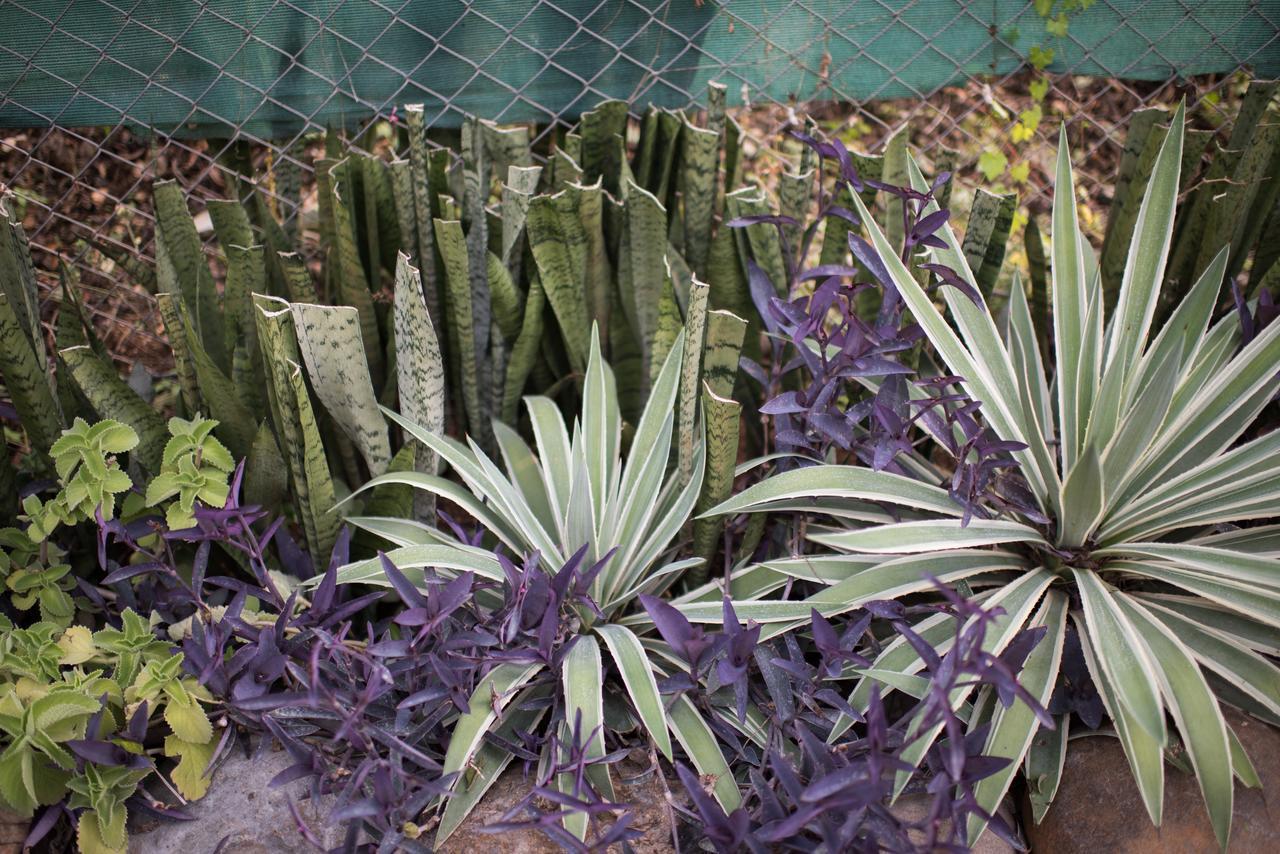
left=0, top=83, right=1280, bottom=851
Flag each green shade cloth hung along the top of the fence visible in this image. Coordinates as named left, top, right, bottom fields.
left=0, top=0, right=1280, bottom=138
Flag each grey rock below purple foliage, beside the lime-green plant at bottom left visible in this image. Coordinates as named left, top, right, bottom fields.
left=129, top=745, right=344, bottom=854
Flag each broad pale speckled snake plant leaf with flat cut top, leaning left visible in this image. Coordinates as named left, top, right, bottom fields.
left=292, top=302, right=392, bottom=475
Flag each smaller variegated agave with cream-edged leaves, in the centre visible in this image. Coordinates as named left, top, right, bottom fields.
left=318, top=325, right=740, bottom=844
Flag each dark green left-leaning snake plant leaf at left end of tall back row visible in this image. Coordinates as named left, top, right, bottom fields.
left=152, top=181, right=230, bottom=371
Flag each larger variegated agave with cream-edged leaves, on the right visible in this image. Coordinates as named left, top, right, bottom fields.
left=696, top=109, right=1280, bottom=846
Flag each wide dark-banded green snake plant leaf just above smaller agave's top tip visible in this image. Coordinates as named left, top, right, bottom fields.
left=527, top=196, right=590, bottom=373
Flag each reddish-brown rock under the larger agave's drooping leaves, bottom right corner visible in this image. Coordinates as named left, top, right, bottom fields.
left=1027, top=711, right=1280, bottom=854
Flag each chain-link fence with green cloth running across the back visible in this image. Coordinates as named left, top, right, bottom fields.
left=0, top=0, right=1280, bottom=365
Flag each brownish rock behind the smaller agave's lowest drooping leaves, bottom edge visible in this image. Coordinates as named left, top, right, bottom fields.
left=439, top=758, right=675, bottom=854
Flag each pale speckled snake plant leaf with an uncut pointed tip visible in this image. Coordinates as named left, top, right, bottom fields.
left=394, top=252, right=445, bottom=522
